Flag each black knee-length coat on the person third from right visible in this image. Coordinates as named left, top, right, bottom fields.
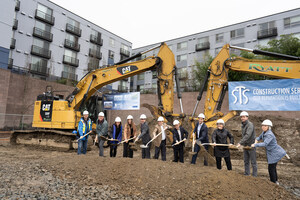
left=212, top=128, right=234, bottom=157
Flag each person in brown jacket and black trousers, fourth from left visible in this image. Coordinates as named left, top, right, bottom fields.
left=123, top=115, right=137, bottom=158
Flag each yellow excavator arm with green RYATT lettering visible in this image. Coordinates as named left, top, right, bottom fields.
left=189, top=44, right=300, bottom=130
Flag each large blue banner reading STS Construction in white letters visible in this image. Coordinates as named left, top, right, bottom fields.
left=228, top=79, right=300, bottom=111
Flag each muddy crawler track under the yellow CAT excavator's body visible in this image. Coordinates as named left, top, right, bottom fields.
left=10, top=129, right=77, bottom=150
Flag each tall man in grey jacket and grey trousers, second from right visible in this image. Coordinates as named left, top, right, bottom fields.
left=237, top=111, right=257, bottom=177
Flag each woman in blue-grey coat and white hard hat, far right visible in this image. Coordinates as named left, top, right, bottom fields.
left=251, top=119, right=286, bottom=184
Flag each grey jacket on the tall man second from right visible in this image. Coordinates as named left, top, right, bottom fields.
left=240, top=120, right=255, bottom=146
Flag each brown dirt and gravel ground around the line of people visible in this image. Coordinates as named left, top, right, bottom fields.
left=0, top=116, right=300, bottom=199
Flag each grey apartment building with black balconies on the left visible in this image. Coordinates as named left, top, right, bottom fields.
left=0, top=0, right=132, bottom=89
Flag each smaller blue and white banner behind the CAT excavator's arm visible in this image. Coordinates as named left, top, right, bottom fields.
left=103, top=92, right=140, bottom=110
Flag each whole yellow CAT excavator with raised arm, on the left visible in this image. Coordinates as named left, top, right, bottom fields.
left=11, top=43, right=185, bottom=149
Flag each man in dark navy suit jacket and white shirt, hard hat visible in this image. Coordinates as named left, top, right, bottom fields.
left=191, top=113, right=209, bottom=166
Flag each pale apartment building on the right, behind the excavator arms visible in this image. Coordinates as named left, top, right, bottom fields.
left=130, top=8, right=300, bottom=92
